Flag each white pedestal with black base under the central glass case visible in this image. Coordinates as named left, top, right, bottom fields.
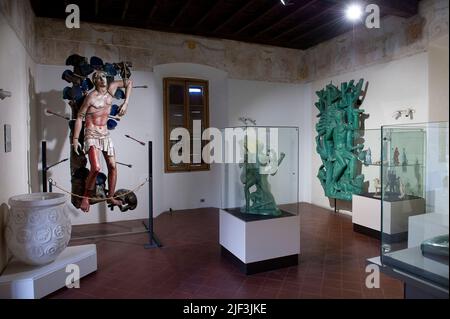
left=219, top=210, right=300, bottom=274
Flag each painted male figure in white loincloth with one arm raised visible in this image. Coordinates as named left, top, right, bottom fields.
left=72, top=71, right=132, bottom=212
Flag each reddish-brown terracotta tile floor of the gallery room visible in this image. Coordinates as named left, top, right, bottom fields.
left=49, top=204, right=403, bottom=299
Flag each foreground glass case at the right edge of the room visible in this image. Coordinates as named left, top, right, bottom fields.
left=381, top=122, right=449, bottom=291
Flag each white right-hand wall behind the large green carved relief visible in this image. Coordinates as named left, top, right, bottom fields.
left=311, top=53, right=429, bottom=212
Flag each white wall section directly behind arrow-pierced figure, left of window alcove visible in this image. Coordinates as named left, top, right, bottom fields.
left=33, top=65, right=155, bottom=225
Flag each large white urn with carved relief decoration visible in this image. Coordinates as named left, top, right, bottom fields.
left=6, top=193, right=72, bottom=265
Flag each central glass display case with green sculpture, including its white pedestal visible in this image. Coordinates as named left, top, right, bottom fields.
left=219, top=126, right=300, bottom=274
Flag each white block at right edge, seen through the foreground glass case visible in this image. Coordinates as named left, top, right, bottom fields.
left=408, top=213, right=448, bottom=248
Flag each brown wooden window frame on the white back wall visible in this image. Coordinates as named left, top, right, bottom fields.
left=163, top=77, right=210, bottom=173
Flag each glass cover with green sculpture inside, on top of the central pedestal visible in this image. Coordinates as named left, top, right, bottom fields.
left=222, top=126, right=299, bottom=219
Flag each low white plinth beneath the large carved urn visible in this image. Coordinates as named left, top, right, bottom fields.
left=0, top=244, right=97, bottom=299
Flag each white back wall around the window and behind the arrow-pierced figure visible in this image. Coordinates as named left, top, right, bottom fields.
left=35, top=63, right=311, bottom=228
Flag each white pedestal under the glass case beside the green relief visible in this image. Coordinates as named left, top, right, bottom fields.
left=352, top=195, right=425, bottom=242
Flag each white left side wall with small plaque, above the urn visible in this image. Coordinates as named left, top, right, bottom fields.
left=0, top=13, right=34, bottom=271
